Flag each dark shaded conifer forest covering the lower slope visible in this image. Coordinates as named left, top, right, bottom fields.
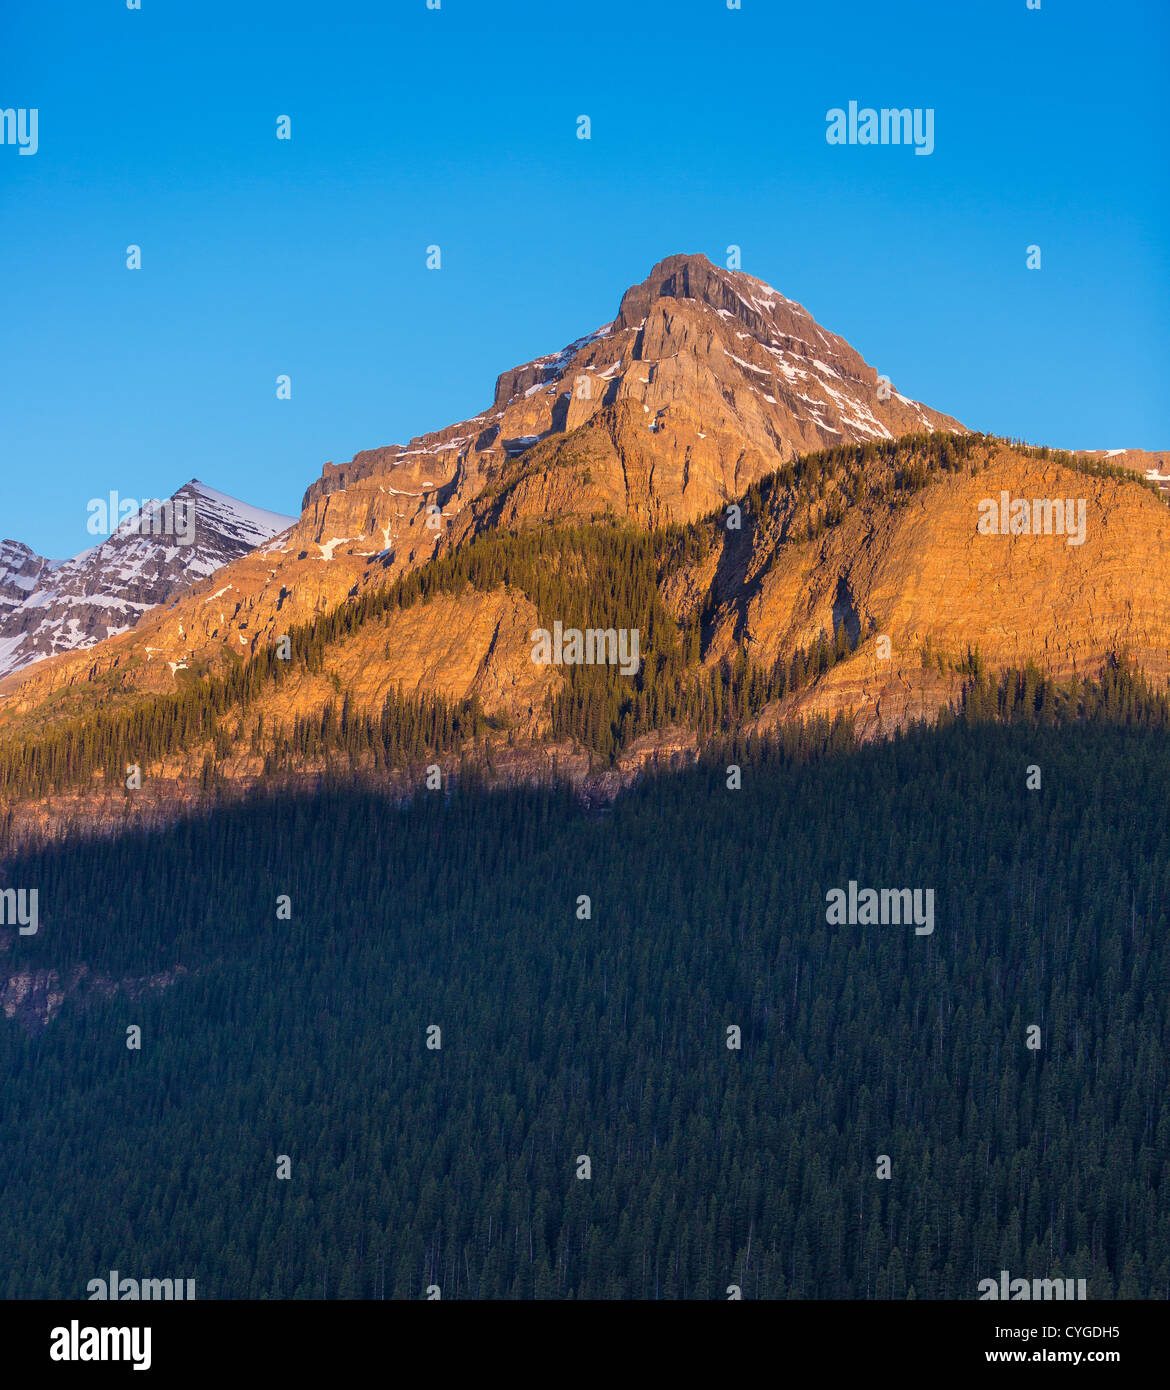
left=0, top=706, right=1170, bottom=1300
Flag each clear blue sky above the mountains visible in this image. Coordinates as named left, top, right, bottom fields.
left=0, top=0, right=1170, bottom=556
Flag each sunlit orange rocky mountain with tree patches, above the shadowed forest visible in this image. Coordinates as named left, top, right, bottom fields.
left=0, top=256, right=1170, bottom=834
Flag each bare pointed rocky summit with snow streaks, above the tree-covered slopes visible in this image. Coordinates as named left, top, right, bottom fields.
left=303, top=253, right=963, bottom=533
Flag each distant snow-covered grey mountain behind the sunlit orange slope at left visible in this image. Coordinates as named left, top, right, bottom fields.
left=0, top=478, right=296, bottom=677
